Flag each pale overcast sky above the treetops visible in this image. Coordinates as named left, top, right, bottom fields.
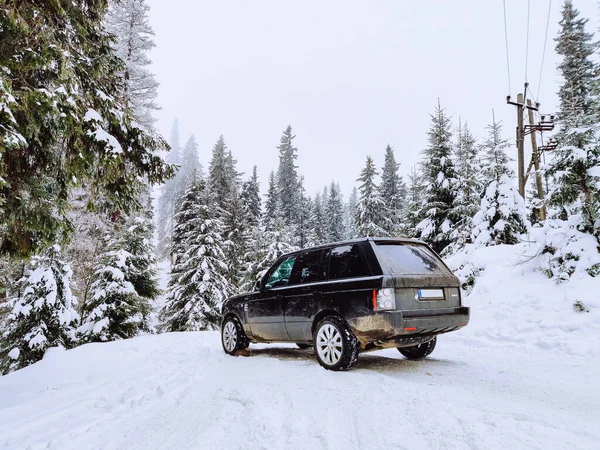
left=148, top=0, right=600, bottom=197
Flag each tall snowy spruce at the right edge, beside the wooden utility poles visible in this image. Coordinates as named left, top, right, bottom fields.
left=548, top=0, right=600, bottom=237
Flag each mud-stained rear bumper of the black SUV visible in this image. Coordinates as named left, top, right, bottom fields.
left=347, top=306, right=470, bottom=350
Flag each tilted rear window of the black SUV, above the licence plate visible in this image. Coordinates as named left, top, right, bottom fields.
left=377, top=243, right=448, bottom=275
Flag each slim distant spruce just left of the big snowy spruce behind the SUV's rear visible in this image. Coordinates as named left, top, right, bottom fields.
left=379, top=144, right=406, bottom=236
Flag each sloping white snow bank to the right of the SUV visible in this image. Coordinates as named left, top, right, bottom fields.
left=446, top=243, right=600, bottom=356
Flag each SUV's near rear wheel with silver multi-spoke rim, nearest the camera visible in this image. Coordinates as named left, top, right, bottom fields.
left=313, top=316, right=359, bottom=371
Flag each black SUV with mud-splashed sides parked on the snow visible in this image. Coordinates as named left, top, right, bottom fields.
left=221, top=238, right=469, bottom=370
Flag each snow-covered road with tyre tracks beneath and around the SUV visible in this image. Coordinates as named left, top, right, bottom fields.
left=0, top=330, right=600, bottom=450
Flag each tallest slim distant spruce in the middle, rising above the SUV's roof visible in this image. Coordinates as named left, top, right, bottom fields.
left=277, top=125, right=300, bottom=227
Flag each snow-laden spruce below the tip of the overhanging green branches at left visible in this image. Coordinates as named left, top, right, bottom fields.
left=78, top=215, right=160, bottom=342
